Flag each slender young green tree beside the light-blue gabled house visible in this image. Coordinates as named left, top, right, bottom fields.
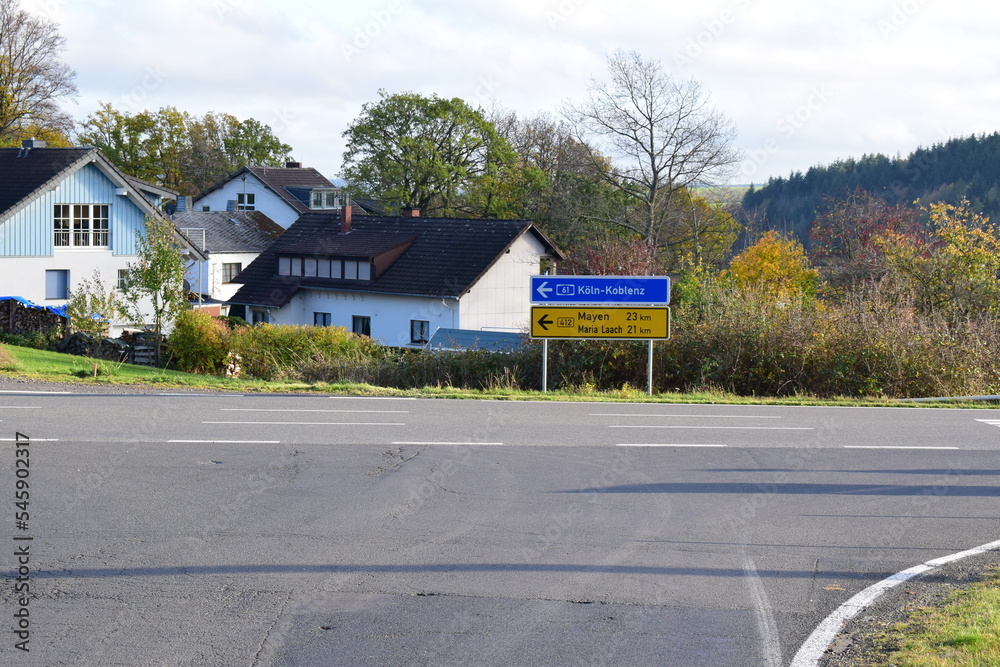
left=123, top=216, right=188, bottom=364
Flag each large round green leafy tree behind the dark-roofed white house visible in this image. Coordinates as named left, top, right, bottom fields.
left=343, top=90, right=516, bottom=217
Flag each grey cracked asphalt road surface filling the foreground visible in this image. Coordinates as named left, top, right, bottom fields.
left=0, top=384, right=1000, bottom=667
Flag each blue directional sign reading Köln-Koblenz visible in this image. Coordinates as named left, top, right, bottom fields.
left=531, top=276, right=670, bottom=305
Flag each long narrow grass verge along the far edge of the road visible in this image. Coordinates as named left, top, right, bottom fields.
left=0, top=344, right=995, bottom=408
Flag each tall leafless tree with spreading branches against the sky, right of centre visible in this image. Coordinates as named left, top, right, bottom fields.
left=563, top=50, right=740, bottom=245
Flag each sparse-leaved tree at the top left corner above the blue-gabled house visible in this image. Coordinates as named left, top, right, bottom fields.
left=0, top=0, right=77, bottom=143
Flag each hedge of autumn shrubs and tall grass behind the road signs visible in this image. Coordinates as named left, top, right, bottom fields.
left=166, top=281, right=1000, bottom=398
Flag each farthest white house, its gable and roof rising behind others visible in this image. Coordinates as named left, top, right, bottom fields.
left=190, top=162, right=371, bottom=229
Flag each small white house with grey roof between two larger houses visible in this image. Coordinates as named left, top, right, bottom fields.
left=170, top=211, right=285, bottom=306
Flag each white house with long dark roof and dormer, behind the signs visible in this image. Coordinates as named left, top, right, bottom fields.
left=230, top=208, right=561, bottom=346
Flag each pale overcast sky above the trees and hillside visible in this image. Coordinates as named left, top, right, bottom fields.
left=21, top=0, right=1000, bottom=189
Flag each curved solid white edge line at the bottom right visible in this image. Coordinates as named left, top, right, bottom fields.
left=789, top=541, right=1000, bottom=667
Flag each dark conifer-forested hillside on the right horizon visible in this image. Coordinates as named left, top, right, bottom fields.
left=743, top=132, right=1000, bottom=247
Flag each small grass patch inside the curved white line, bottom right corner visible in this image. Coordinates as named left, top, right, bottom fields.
left=866, top=569, right=1000, bottom=667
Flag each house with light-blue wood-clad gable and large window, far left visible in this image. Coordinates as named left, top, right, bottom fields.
left=0, top=140, right=202, bottom=332
